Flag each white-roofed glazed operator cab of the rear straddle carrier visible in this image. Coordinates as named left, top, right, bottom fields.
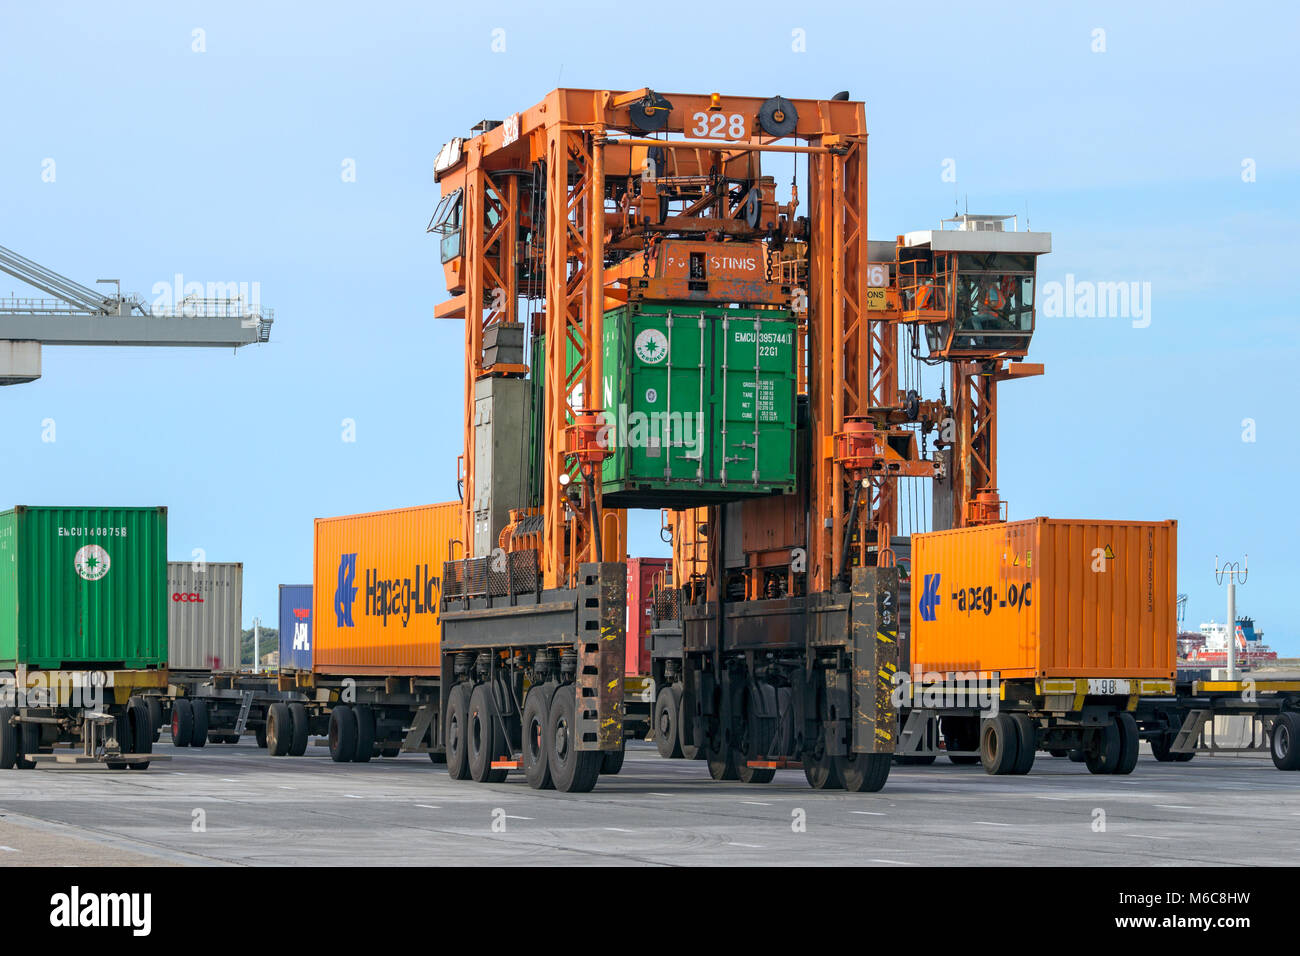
left=898, top=213, right=1052, bottom=359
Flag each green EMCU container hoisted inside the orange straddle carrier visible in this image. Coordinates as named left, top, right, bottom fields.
left=602, top=302, right=797, bottom=507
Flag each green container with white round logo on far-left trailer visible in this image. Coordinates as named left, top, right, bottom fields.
left=0, top=506, right=168, bottom=670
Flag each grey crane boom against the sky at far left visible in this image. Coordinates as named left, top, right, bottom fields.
left=0, top=246, right=274, bottom=385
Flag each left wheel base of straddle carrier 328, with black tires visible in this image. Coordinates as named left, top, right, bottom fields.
left=437, top=551, right=628, bottom=792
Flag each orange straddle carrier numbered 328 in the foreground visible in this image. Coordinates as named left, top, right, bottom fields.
left=429, top=88, right=935, bottom=791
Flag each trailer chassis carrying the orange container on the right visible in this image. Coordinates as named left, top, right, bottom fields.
left=896, top=674, right=1175, bottom=775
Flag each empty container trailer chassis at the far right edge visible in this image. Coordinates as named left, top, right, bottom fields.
left=1136, top=674, right=1300, bottom=770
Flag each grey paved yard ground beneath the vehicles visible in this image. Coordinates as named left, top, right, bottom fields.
left=0, top=739, right=1284, bottom=866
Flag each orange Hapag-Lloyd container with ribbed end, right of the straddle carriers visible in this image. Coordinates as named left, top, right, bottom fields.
left=911, top=518, right=1178, bottom=678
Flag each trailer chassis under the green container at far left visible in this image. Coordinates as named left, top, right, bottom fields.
left=0, top=669, right=170, bottom=770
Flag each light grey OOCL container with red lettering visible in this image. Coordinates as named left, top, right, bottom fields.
left=166, top=561, right=243, bottom=672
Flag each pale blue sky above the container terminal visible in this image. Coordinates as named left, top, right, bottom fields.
left=0, top=3, right=1300, bottom=654
